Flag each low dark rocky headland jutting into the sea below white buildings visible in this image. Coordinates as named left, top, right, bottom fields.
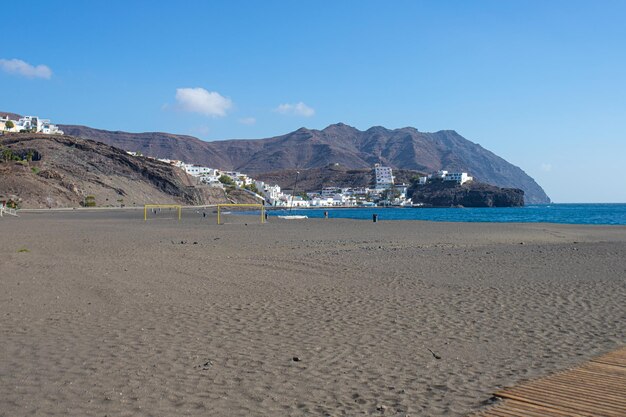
left=411, top=181, right=524, bottom=207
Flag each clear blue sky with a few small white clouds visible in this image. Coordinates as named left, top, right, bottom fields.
left=0, top=0, right=626, bottom=202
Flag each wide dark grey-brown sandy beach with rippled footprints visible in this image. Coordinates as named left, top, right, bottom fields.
left=0, top=210, right=626, bottom=417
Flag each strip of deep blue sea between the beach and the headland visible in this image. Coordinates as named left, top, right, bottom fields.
left=268, top=204, right=626, bottom=225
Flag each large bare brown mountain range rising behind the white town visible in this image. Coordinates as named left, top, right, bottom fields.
left=60, top=123, right=550, bottom=203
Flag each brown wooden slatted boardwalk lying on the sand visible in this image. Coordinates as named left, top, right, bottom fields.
left=474, top=347, right=626, bottom=417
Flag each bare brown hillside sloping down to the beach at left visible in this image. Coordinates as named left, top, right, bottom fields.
left=0, top=134, right=227, bottom=208
